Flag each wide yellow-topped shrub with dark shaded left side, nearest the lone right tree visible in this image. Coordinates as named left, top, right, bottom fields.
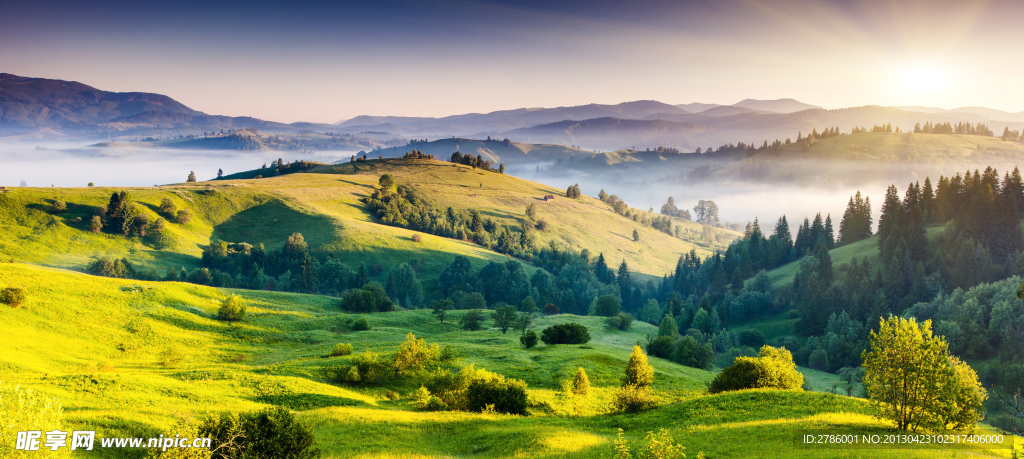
left=708, top=346, right=804, bottom=393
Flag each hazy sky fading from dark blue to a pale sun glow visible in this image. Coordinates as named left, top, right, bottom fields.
left=0, top=0, right=1024, bottom=123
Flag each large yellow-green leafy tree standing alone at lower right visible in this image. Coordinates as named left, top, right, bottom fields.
left=861, top=316, right=986, bottom=431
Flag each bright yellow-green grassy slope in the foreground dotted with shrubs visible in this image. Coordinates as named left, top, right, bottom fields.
left=0, top=263, right=1009, bottom=458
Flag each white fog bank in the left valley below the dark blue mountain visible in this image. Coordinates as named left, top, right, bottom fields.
left=0, top=142, right=355, bottom=186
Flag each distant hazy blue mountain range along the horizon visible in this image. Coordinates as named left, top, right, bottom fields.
left=6, top=74, right=1024, bottom=151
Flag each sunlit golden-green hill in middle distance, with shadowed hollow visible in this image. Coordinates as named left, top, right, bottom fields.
left=0, top=159, right=737, bottom=288
